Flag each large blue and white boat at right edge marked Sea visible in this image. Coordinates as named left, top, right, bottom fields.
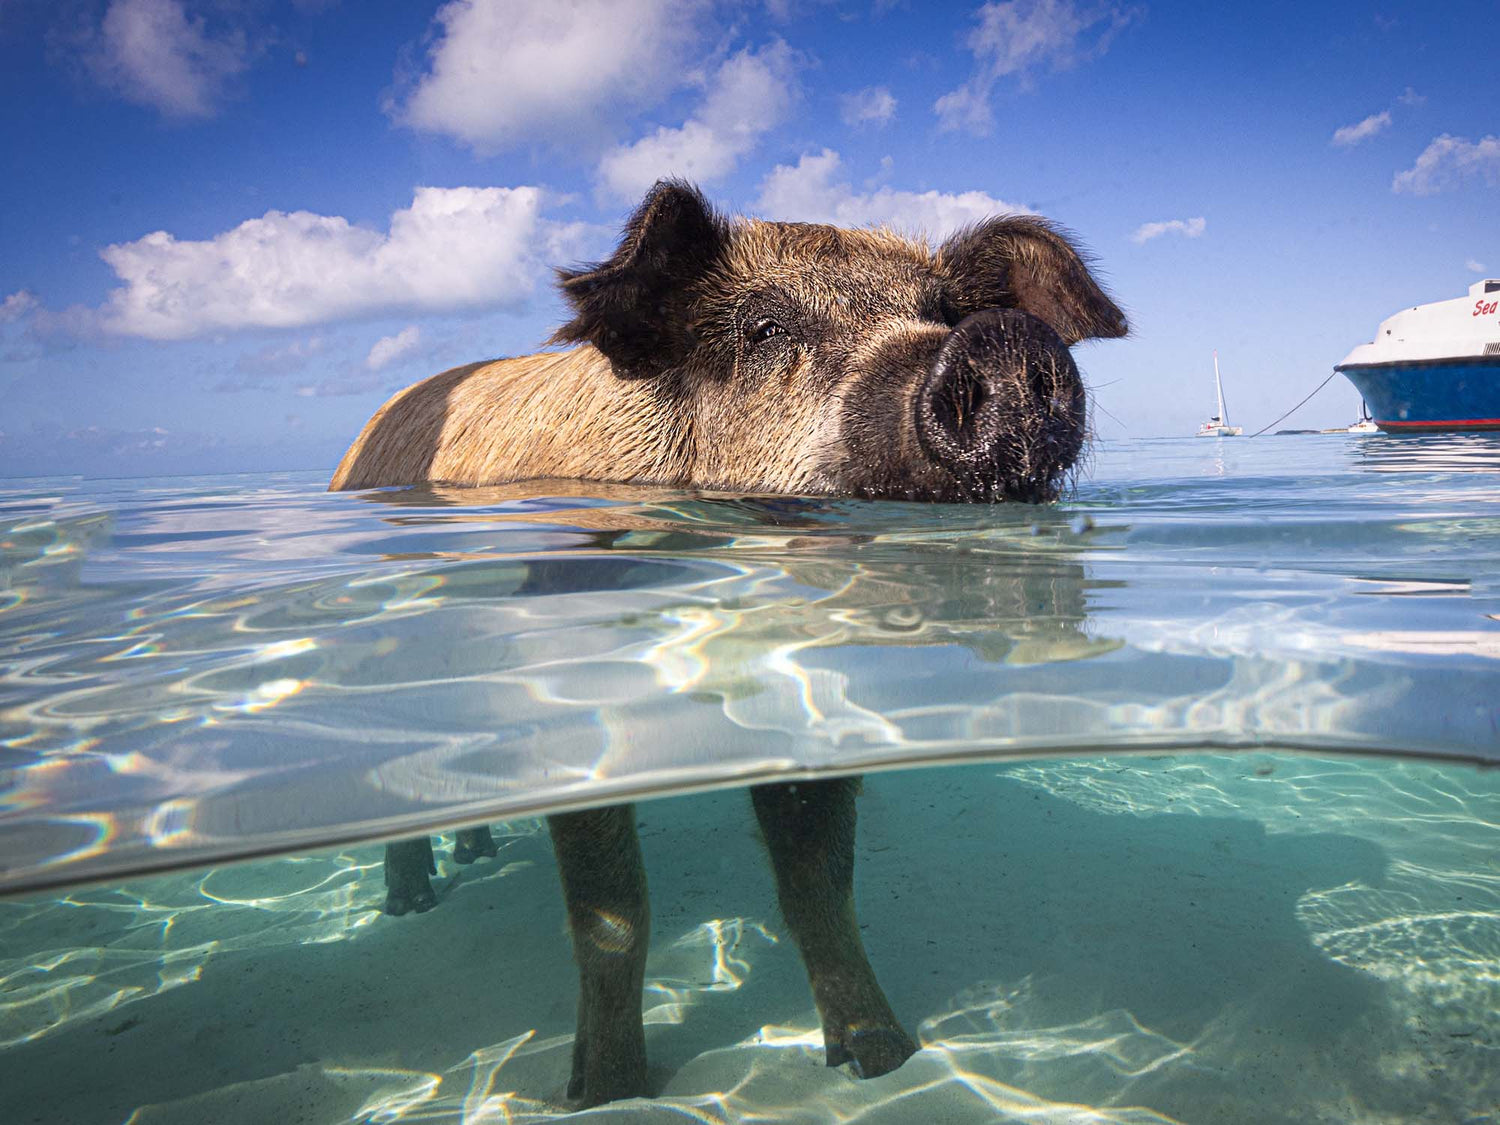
left=1334, top=278, right=1500, bottom=434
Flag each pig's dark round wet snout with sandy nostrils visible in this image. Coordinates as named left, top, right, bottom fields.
left=915, top=309, right=1085, bottom=500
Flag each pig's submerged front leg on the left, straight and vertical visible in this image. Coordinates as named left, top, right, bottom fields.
left=548, top=806, right=651, bottom=1106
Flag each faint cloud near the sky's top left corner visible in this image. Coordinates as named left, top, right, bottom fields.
left=84, top=0, right=249, bottom=117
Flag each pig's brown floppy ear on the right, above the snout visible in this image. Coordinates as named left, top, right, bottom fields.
left=938, top=215, right=1127, bottom=344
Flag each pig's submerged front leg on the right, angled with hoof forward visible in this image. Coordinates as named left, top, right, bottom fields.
left=750, top=779, right=917, bottom=1079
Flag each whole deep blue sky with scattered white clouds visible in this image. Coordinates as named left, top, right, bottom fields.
left=0, top=0, right=1500, bottom=476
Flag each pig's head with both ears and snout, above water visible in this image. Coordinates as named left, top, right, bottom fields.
left=555, top=182, right=1125, bottom=501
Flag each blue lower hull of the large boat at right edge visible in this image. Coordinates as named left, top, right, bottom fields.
left=1335, top=356, right=1500, bottom=434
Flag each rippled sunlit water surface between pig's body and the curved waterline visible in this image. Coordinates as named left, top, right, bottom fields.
left=0, top=435, right=1500, bottom=890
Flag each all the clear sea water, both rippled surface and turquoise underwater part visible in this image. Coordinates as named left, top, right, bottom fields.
left=0, top=437, right=1500, bottom=1125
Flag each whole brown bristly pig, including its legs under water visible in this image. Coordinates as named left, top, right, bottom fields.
left=330, top=180, right=1127, bottom=1106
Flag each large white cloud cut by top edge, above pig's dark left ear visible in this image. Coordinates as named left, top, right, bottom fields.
left=387, top=0, right=704, bottom=153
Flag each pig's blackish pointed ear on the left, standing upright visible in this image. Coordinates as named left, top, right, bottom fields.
left=552, top=180, right=728, bottom=378
